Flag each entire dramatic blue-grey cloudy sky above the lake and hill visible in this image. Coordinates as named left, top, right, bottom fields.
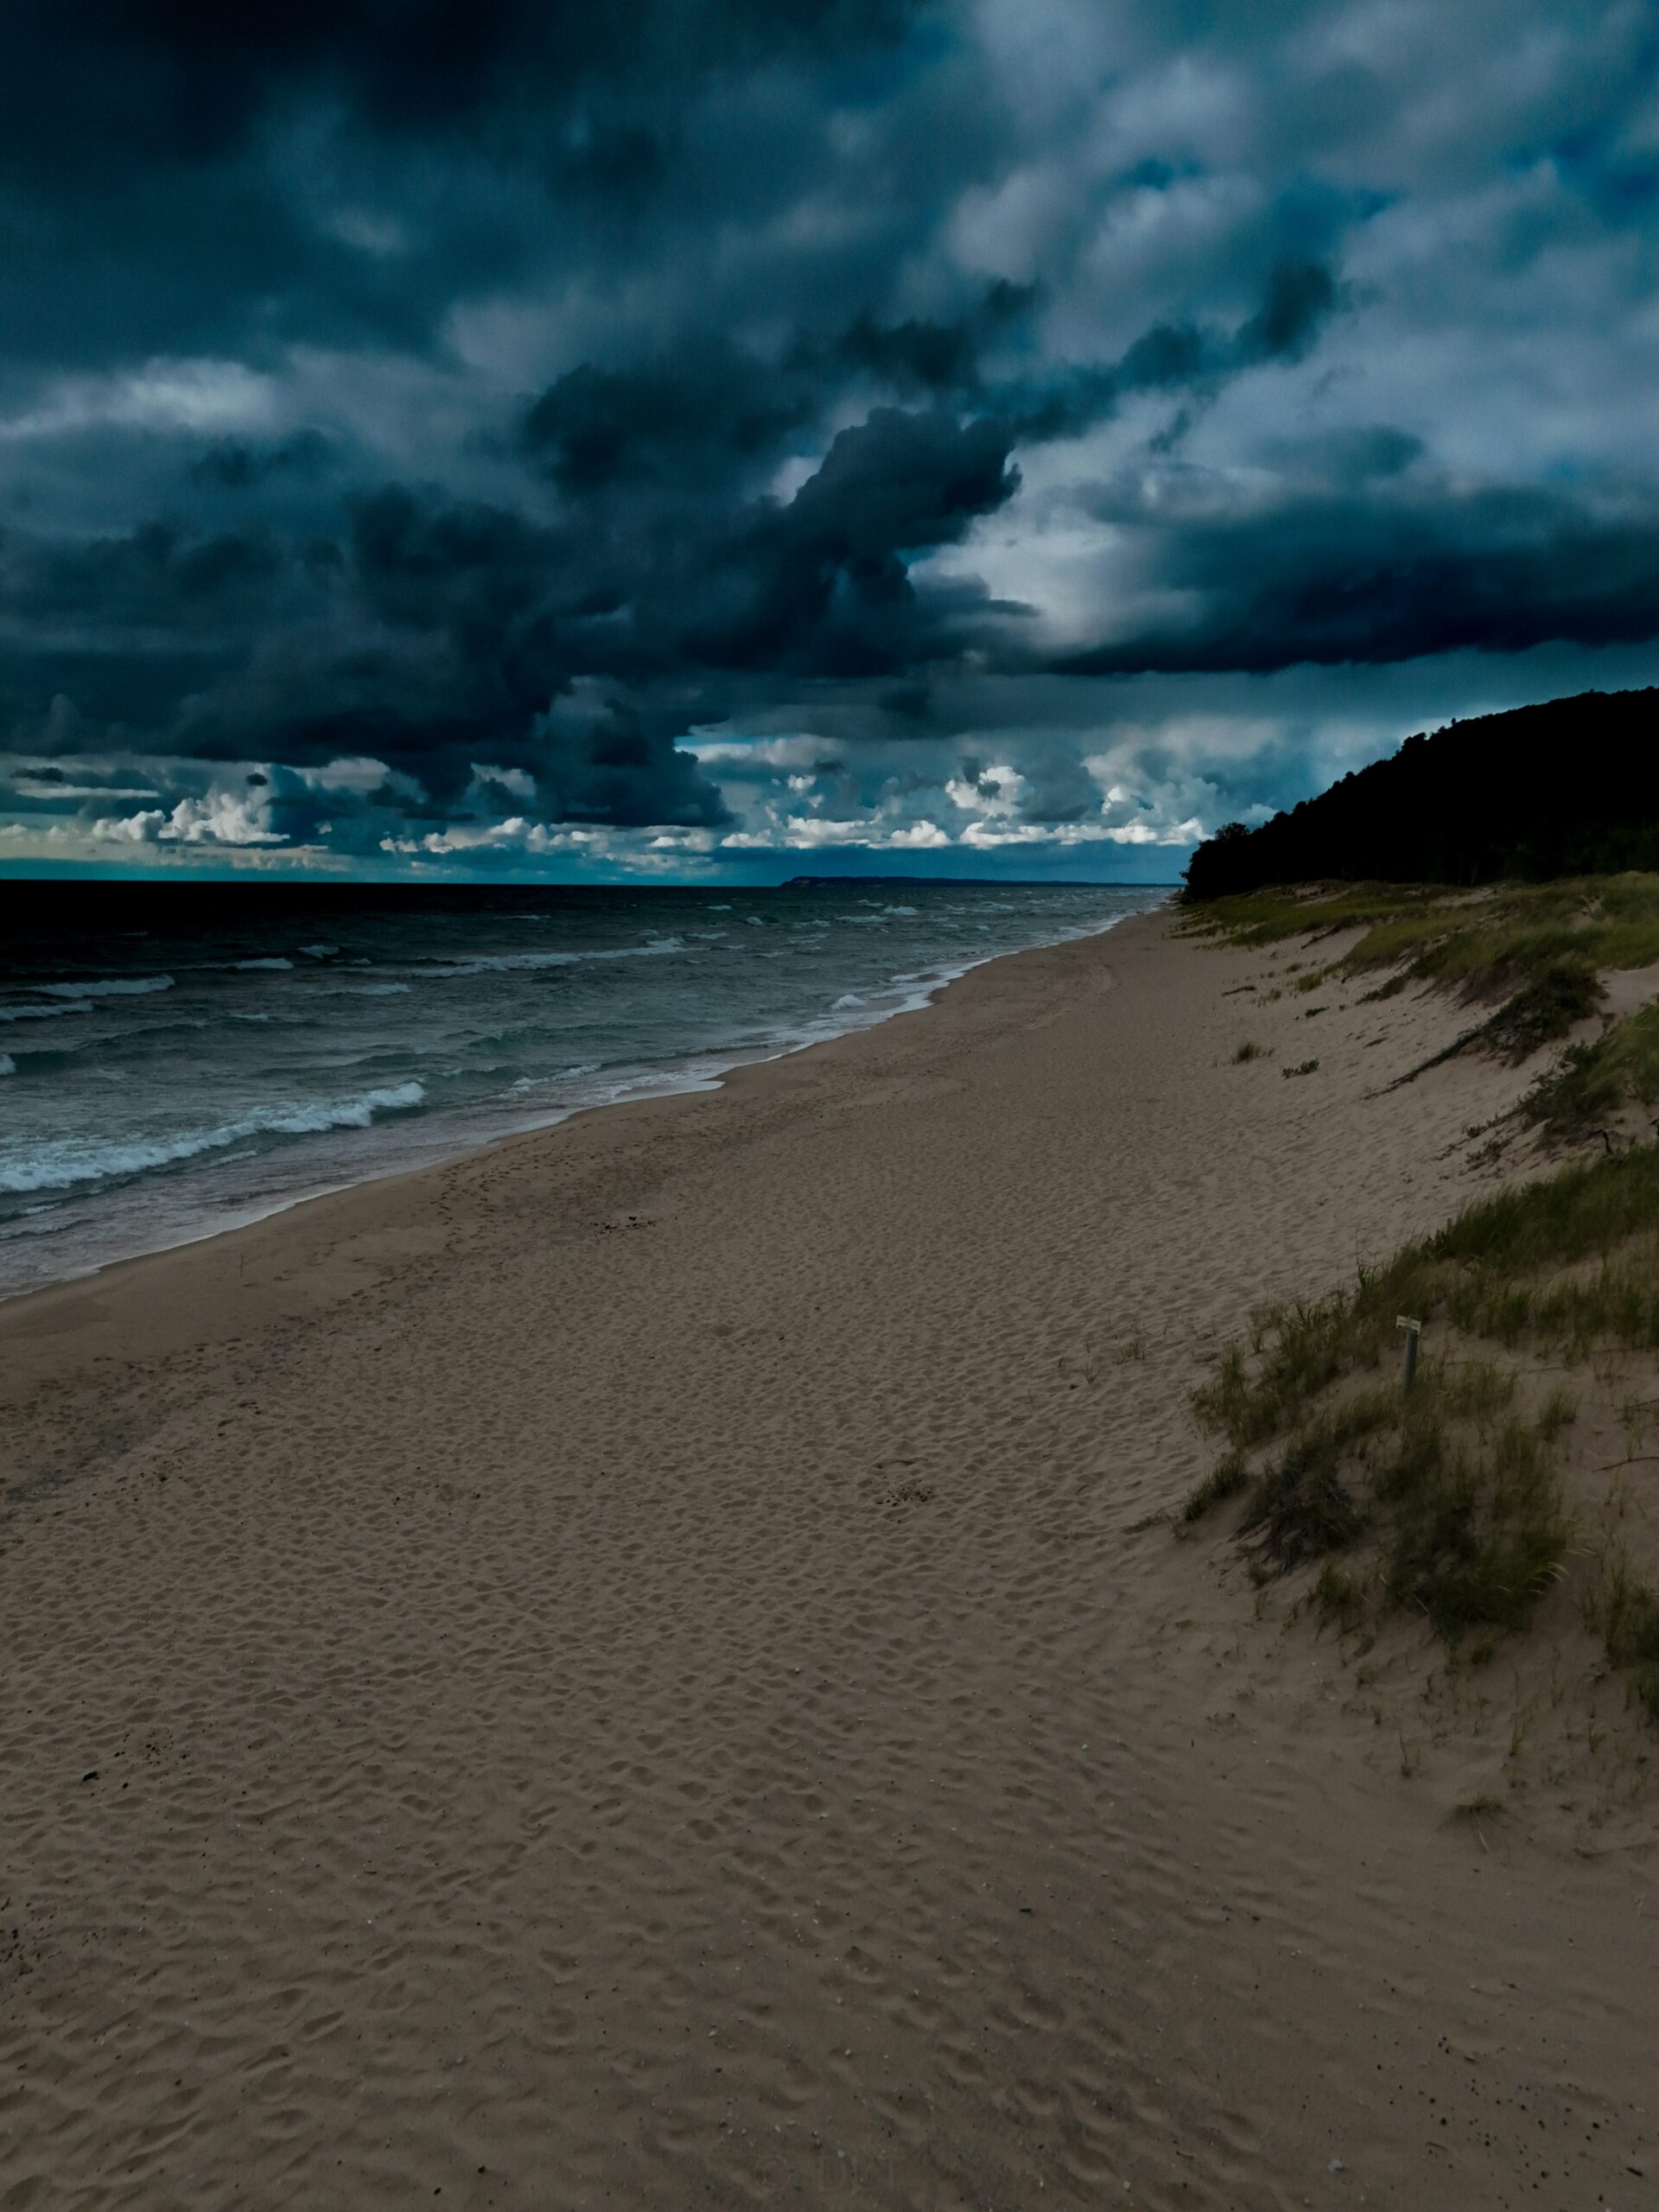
left=0, top=0, right=1659, bottom=882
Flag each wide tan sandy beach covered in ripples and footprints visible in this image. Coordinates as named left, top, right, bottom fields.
left=0, top=916, right=1659, bottom=2212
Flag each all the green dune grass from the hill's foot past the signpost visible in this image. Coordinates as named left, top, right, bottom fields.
left=1177, top=874, right=1659, bottom=1721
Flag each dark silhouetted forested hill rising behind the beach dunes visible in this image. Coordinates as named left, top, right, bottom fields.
left=1185, top=690, right=1659, bottom=900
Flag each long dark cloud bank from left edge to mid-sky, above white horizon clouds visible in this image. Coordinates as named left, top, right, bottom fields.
left=0, top=410, right=1018, bottom=823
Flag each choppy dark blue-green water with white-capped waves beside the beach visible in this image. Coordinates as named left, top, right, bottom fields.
left=0, top=882, right=1166, bottom=1294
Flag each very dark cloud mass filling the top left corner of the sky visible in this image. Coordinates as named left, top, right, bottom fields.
left=0, top=0, right=938, bottom=360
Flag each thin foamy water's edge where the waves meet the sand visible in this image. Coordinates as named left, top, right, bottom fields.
left=0, top=893, right=1173, bottom=1310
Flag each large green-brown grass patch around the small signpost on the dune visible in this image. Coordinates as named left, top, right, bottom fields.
left=1184, top=1148, right=1659, bottom=1681
